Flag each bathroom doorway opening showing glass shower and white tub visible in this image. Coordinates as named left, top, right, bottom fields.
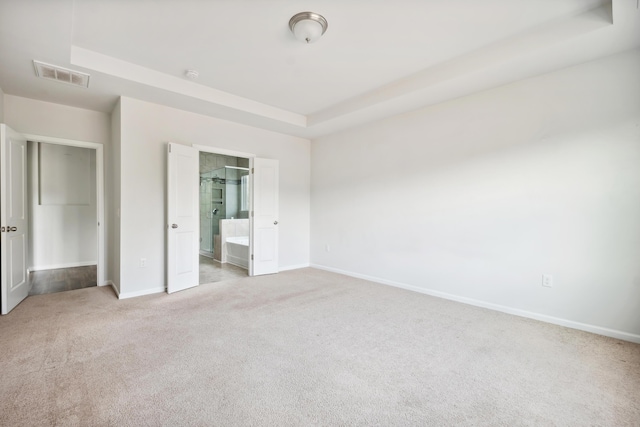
left=199, top=151, right=250, bottom=284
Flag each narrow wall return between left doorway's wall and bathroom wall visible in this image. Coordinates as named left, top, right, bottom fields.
left=106, top=100, right=122, bottom=294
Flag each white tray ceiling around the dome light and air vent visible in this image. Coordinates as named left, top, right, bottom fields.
left=0, top=0, right=640, bottom=138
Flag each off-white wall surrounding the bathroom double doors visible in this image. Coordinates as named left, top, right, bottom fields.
left=120, top=97, right=310, bottom=296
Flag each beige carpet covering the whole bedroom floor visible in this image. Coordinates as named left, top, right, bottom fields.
left=0, top=269, right=640, bottom=426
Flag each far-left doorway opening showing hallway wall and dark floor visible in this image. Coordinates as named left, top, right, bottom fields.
left=27, top=141, right=99, bottom=295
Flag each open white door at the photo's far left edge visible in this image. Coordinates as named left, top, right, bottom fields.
left=0, top=125, right=29, bottom=314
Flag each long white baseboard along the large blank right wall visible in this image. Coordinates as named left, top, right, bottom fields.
left=311, top=264, right=640, bottom=344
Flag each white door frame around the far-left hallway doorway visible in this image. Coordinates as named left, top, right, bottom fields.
left=22, top=133, right=109, bottom=286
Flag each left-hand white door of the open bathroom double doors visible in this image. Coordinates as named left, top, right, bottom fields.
left=167, top=143, right=200, bottom=293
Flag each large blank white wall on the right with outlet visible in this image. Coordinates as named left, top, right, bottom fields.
left=311, top=51, right=640, bottom=341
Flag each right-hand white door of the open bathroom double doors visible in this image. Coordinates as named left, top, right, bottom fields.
left=249, top=158, right=278, bottom=276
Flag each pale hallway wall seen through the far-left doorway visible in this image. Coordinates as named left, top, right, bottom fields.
left=28, top=141, right=97, bottom=271
